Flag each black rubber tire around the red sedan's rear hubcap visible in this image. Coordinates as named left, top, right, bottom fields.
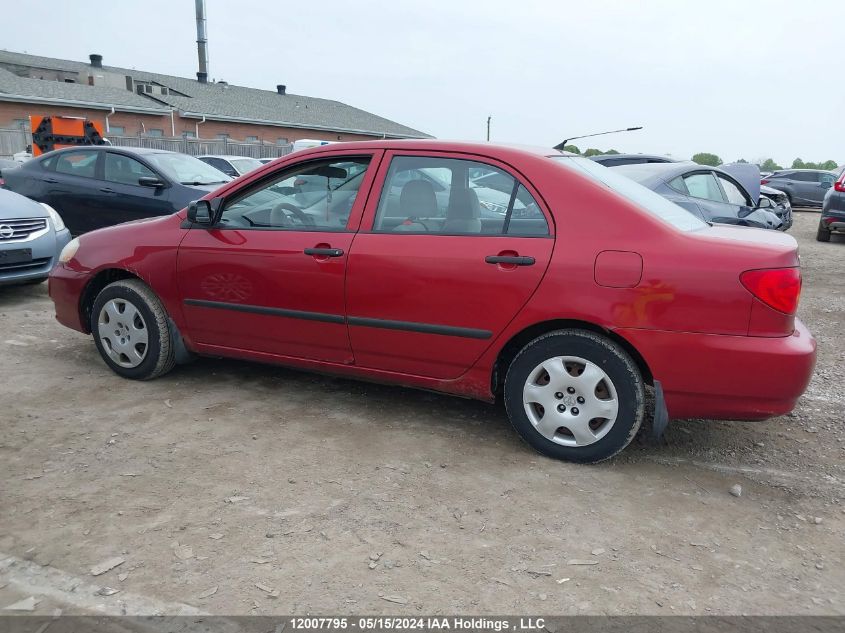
left=504, top=329, right=645, bottom=464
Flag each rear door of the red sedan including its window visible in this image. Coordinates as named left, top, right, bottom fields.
left=346, top=152, right=554, bottom=379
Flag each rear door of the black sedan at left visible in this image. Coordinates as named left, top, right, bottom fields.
left=43, top=149, right=102, bottom=235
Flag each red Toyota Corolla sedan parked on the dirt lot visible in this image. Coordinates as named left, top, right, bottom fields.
left=50, top=141, right=815, bottom=462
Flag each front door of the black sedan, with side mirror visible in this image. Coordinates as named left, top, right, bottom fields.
left=97, top=151, right=173, bottom=228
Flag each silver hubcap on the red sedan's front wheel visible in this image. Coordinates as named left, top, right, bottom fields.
left=97, top=299, right=149, bottom=369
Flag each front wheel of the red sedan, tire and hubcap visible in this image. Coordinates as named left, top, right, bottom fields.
left=91, top=279, right=176, bottom=380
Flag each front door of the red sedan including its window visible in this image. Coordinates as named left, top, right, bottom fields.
left=176, top=152, right=381, bottom=364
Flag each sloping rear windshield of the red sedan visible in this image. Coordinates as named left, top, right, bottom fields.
left=550, top=156, right=707, bottom=231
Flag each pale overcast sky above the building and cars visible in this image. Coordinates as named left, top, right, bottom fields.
left=0, top=0, right=845, bottom=166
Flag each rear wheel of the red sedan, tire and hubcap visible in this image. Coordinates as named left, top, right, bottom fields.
left=505, top=330, right=645, bottom=463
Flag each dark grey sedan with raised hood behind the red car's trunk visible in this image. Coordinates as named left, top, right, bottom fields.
left=611, top=162, right=786, bottom=229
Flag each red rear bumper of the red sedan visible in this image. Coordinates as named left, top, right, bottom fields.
left=616, top=319, right=816, bottom=420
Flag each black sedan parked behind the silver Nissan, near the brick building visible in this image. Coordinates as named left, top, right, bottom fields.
left=2, top=145, right=231, bottom=235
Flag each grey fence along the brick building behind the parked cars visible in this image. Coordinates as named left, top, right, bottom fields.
left=0, top=128, right=293, bottom=158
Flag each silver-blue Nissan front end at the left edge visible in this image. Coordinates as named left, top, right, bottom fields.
left=0, top=189, right=70, bottom=285
